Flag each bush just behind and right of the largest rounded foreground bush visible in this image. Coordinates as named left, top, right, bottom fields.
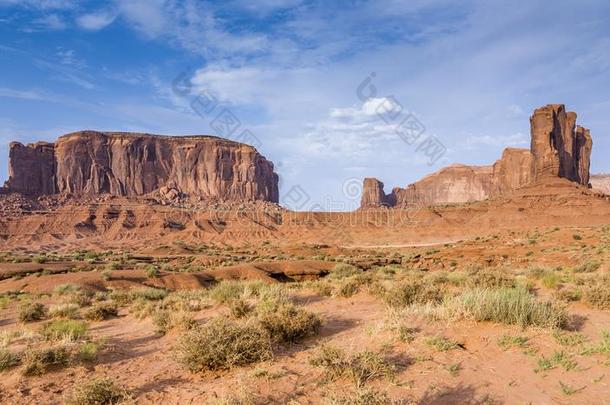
left=259, top=304, right=322, bottom=343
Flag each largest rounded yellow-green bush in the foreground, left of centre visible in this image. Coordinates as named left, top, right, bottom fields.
left=175, top=318, right=272, bottom=373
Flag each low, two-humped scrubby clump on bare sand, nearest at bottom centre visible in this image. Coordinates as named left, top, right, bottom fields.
left=310, top=345, right=396, bottom=387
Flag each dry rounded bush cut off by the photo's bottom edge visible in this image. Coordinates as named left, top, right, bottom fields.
left=67, top=377, right=131, bottom=405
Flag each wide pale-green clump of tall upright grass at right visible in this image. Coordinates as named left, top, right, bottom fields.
left=446, top=288, right=568, bottom=329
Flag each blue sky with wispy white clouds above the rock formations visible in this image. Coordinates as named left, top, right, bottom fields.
left=0, top=0, right=610, bottom=210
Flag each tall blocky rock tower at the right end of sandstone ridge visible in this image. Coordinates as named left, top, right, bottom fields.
left=530, top=104, right=593, bottom=185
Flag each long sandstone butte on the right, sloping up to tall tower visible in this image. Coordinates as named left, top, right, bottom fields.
left=360, top=104, right=592, bottom=209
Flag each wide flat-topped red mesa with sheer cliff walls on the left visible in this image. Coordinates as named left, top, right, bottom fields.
left=6, top=131, right=279, bottom=202
